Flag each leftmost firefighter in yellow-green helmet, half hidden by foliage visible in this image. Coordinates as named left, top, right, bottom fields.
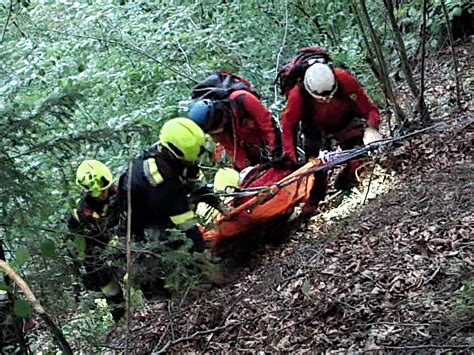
left=67, top=160, right=125, bottom=321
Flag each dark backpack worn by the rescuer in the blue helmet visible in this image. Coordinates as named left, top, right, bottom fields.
left=191, top=70, right=260, bottom=101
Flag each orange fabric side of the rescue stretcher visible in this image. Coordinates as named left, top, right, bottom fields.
left=202, top=159, right=321, bottom=243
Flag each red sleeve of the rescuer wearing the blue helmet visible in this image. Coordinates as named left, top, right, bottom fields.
left=231, top=90, right=276, bottom=152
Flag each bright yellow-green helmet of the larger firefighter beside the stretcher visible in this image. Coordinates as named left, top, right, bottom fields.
left=160, top=118, right=206, bottom=162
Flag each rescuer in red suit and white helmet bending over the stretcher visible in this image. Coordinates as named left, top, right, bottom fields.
left=281, top=61, right=382, bottom=215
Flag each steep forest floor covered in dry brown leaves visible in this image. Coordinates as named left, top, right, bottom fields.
left=108, top=47, right=474, bottom=353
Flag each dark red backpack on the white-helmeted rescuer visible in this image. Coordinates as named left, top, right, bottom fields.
left=275, top=46, right=331, bottom=96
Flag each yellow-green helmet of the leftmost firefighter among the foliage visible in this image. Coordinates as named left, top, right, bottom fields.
left=76, top=160, right=114, bottom=197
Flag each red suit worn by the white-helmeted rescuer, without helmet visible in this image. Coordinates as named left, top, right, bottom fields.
left=282, top=68, right=380, bottom=210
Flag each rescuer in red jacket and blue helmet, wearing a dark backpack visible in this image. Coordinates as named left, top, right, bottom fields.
left=188, top=71, right=279, bottom=170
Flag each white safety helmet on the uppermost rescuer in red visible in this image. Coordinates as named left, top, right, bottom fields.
left=304, top=63, right=337, bottom=100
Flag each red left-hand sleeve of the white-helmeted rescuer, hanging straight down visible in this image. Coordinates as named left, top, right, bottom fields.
left=281, top=86, right=304, bottom=162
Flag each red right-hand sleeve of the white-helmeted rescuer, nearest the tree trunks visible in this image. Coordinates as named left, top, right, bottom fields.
left=334, top=69, right=380, bottom=128
